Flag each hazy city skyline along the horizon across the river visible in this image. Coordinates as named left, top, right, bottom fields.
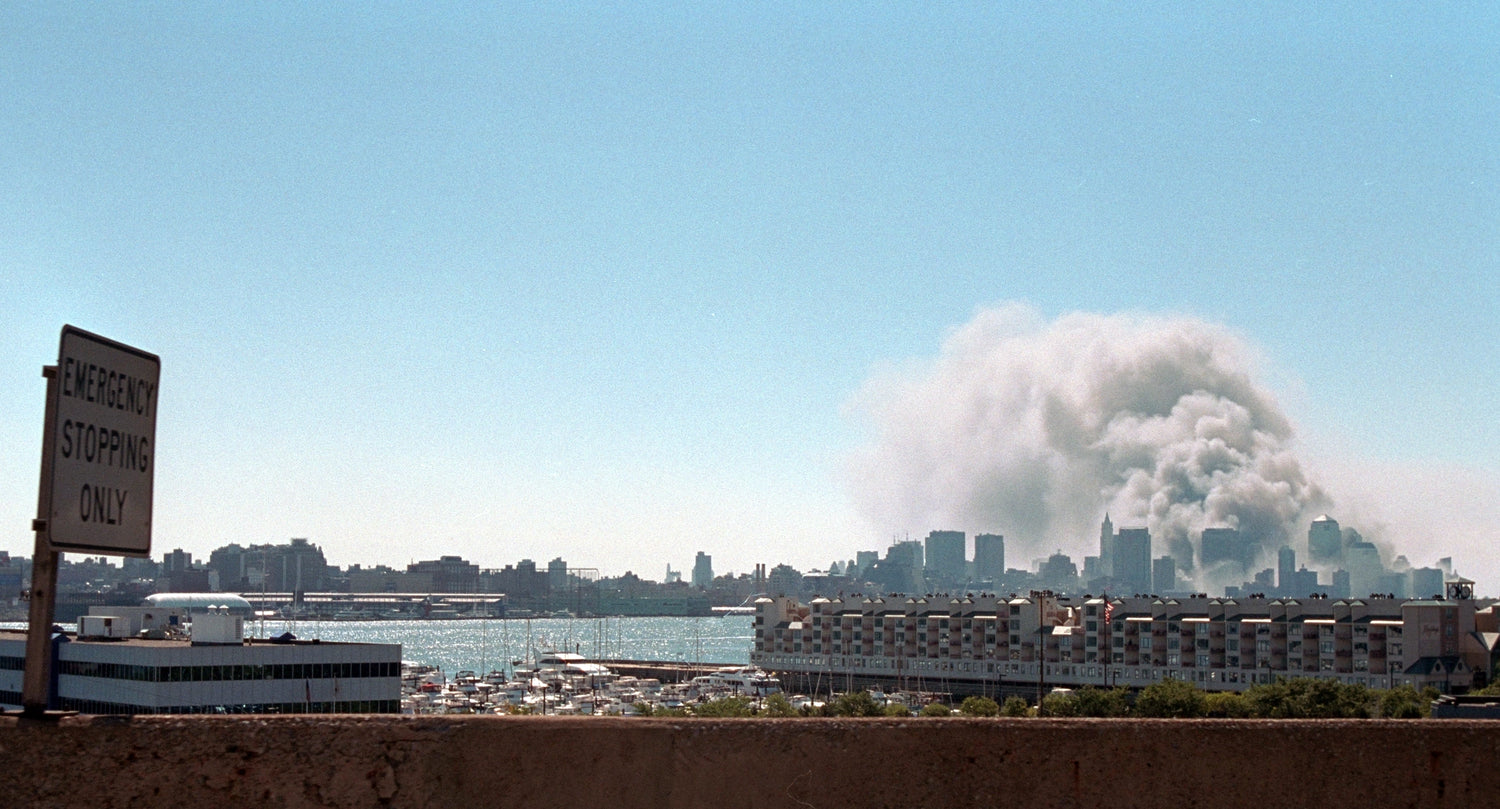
left=43, top=515, right=1490, bottom=606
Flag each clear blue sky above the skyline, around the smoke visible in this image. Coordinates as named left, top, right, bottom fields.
left=0, top=3, right=1500, bottom=578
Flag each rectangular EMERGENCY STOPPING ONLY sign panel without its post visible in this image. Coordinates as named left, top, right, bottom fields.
left=48, top=326, right=162, bottom=557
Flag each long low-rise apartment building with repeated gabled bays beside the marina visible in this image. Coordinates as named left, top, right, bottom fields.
left=752, top=593, right=1500, bottom=693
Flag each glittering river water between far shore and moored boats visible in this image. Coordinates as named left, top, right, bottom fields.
left=255, top=615, right=753, bottom=675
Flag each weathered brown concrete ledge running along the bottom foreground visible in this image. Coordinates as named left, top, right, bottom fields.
left=0, top=716, right=1500, bottom=809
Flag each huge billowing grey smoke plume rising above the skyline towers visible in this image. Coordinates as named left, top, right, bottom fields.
left=852, top=305, right=1329, bottom=585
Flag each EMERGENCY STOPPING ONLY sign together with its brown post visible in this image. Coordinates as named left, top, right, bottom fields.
left=21, top=326, right=162, bottom=716
